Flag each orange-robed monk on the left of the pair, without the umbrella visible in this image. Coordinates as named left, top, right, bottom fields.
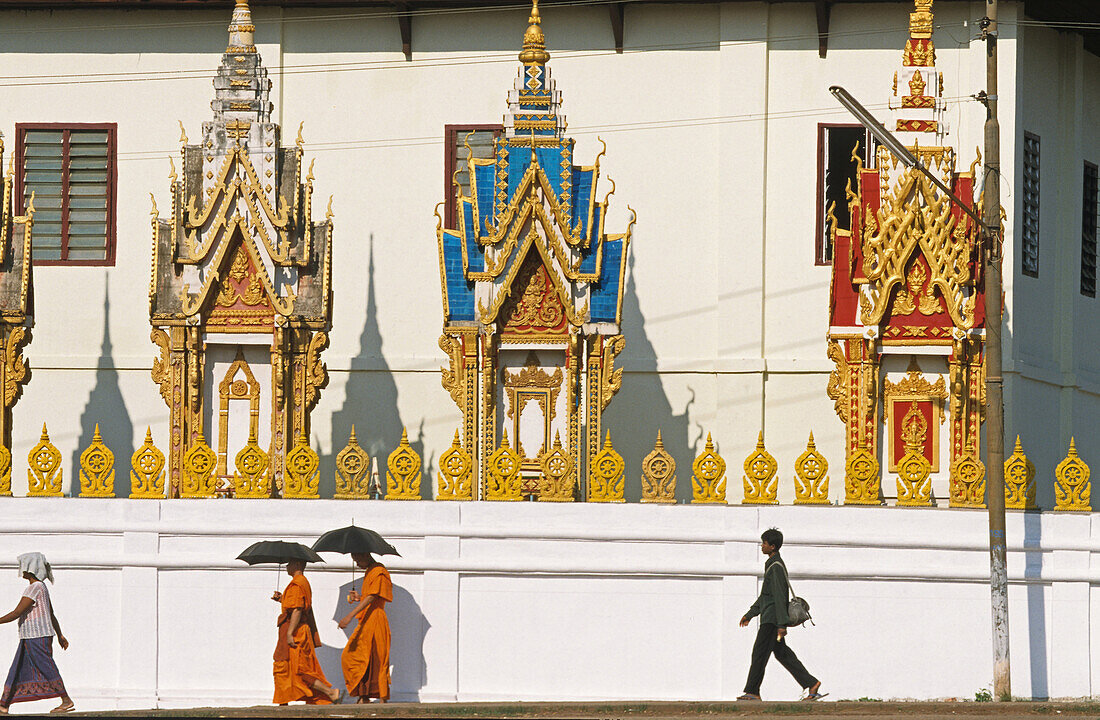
left=272, top=560, right=340, bottom=705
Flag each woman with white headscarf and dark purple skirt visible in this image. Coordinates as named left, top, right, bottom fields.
left=0, top=553, right=75, bottom=715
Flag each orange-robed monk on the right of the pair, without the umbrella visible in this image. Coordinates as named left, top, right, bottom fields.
left=340, top=553, right=394, bottom=702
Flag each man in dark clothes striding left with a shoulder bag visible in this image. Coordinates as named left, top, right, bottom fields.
left=737, top=528, right=827, bottom=700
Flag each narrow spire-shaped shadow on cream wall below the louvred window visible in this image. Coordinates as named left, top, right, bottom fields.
left=68, top=274, right=134, bottom=497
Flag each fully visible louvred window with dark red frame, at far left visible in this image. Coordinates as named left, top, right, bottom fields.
left=15, top=124, right=117, bottom=265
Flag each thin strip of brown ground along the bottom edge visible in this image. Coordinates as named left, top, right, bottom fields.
left=66, top=700, right=1100, bottom=720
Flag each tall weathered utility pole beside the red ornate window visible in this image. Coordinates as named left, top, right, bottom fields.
left=981, top=0, right=1012, bottom=700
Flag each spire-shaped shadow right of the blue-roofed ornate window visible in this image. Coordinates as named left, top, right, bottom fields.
left=604, top=248, right=703, bottom=502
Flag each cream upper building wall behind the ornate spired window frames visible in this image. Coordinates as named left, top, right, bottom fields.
left=0, top=2, right=1100, bottom=496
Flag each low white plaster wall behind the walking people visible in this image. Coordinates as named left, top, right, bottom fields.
left=0, top=499, right=1100, bottom=710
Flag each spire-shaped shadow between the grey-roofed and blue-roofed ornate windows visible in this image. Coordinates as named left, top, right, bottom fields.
left=319, top=239, right=431, bottom=499
